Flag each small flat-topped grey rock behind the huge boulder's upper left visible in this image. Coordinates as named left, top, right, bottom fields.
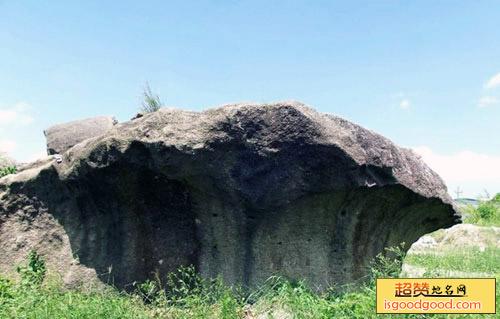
left=43, top=116, right=118, bottom=155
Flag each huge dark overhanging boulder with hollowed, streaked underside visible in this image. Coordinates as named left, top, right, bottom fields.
left=0, top=101, right=460, bottom=290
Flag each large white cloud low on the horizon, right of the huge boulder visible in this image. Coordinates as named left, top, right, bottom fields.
left=413, top=146, right=500, bottom=197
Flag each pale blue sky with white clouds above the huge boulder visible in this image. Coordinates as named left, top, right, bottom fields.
left=0, top=0, right=500, bottom=197
